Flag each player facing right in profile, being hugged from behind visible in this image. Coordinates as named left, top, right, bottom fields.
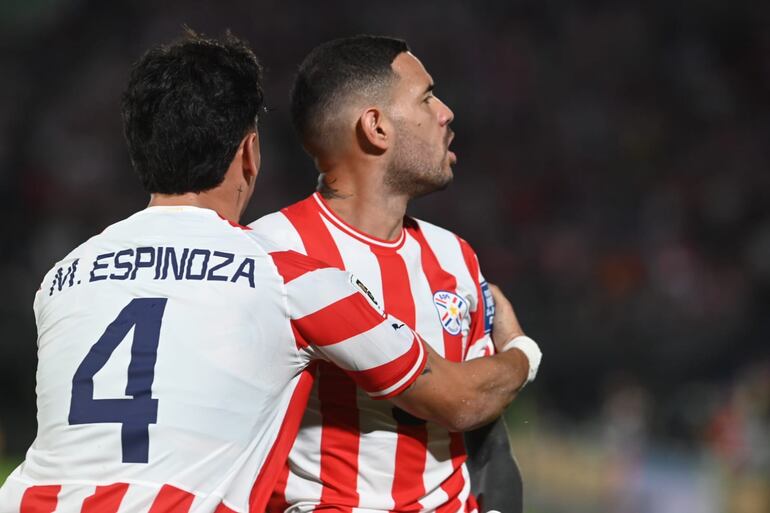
left=251, top=36, right=540, bottom=513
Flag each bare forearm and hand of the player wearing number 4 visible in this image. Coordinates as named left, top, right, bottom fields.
left=392, top=286, right=530, bottom=431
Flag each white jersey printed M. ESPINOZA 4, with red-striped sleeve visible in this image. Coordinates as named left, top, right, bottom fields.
left=0, top=207, right=426, bottom=513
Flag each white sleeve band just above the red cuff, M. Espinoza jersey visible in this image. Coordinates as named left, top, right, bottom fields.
left=317, top=316, right=422, bottom=371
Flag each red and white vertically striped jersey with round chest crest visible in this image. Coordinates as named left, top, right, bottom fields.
left=250, top=194, right=494, bottom=513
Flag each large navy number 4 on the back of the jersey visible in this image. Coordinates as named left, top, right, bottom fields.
left=69, top=298, right=167, bottom=463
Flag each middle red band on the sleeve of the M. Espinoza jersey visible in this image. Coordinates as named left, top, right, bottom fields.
left=291, top=292, right=383, bottom=346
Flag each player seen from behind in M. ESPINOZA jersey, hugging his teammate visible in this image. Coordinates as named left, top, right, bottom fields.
left=0, top=34, right=528, bottom=513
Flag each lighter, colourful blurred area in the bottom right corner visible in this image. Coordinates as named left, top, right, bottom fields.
left=508, top=365, right=770, bottom=513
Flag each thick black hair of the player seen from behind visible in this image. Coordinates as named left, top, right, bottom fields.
left=122, top=29, right=263, bottom=194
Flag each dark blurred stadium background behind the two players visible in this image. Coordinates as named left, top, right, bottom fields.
left=0, top=0, right=770, bottom=513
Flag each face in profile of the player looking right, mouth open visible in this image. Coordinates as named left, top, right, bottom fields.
left=386, top=53, right=450, bottom=198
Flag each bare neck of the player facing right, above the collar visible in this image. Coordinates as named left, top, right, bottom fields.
left=318, top=175, right=409, bottom=240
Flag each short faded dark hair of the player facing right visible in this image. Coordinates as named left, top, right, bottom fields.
left=291, top=35, right=409, bottom=152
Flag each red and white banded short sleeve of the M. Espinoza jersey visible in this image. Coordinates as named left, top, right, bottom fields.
left=271, top=251, right=427, bottom=399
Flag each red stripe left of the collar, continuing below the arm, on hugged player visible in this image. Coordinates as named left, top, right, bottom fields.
left=281, top=197, right=359, bottom=512
